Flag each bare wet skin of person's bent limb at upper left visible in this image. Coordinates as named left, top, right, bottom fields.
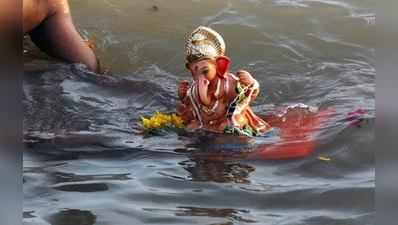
left=22, top=0, right=99, bottom=72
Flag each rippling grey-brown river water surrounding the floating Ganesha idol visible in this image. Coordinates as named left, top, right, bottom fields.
left=23, top=0, right=376, bottom=225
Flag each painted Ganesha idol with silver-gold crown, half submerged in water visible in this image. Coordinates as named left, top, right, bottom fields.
left=177, top=26, right=272, bottom=136
